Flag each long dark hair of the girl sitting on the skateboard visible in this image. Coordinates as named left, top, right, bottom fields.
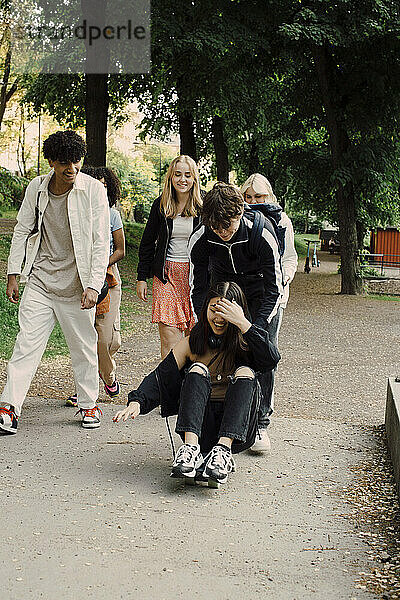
left=189, top=281, right=251, bottom=372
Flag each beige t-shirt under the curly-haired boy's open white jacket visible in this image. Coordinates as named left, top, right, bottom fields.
left=29, top=191, right=83, bottom=301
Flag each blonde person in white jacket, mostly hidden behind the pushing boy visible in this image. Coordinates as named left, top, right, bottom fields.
left=241, top=173, right=297, bottom=452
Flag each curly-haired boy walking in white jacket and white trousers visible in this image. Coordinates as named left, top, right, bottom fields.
left=0, top=131, right=110, bottom=433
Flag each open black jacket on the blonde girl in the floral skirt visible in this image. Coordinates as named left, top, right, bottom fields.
left=137, top=196, right=200, bottom=283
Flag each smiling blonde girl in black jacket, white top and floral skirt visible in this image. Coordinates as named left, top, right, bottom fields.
left=136, top=155, right=202, bottom=358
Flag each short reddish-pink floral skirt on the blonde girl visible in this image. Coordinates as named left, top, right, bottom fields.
left=151, top=260, right=194, bottom=331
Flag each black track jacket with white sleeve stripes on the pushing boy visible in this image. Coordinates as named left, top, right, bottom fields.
left=189, top=206, right=283, bottom=329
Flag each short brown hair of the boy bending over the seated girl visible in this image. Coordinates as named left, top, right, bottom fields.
left=202, top=181, right=244, bottom=230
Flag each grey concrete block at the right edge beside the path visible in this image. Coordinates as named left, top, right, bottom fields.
left=385, top=377, right=400, bottom=498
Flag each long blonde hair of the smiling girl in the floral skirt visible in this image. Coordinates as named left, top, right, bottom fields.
left=160, top=154, right=203, bottom=219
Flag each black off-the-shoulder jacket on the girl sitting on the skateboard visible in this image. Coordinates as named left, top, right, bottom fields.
left=128, top=325, right=280, bottom=417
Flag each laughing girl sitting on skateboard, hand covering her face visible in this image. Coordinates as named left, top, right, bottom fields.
left=113, top=282, right=280, bottom=485
